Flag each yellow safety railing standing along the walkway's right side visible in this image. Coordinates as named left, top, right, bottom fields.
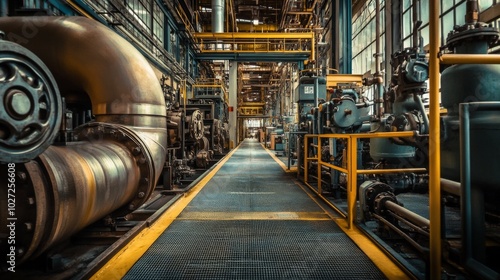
left=304, top=131, right=427, bottom=228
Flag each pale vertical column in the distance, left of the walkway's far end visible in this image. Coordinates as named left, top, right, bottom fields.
left=228, top=61, right=238, bottom=148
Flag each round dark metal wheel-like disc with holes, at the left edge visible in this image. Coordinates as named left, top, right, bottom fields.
left=0, top=38, right=62, bottom=163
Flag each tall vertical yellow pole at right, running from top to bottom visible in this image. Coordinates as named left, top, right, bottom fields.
left=429, top=1, right=441, bottom=279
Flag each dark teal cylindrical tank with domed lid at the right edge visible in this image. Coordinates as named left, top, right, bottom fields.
left=441, top=23, right=500, bottom=189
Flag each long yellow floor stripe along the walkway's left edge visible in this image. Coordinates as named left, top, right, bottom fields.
left=90, top=146, right=239, bottom=280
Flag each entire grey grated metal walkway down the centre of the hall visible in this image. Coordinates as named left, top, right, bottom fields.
left=99, top=139, right=404, bottom=280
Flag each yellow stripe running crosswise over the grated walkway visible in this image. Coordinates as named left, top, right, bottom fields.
left=177, top=212, right=331, bottom=221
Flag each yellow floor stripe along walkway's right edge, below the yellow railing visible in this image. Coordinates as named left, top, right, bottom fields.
left=294, top=181, right=412, bottom=280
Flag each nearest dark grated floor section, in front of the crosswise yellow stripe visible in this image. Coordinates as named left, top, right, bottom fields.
left=124, top=220, right=385, bottom=279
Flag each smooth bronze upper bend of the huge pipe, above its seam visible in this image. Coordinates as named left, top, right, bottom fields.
left=0, top=17, right=166, bottom=118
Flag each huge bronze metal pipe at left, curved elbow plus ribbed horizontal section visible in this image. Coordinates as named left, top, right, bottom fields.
left=0, top=17, right=167, bottom=261
